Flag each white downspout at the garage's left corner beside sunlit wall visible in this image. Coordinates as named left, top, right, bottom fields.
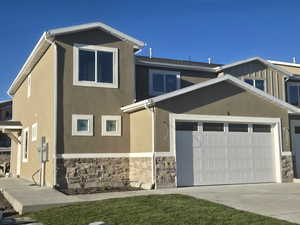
left=144, top=101, right=157, bottom=189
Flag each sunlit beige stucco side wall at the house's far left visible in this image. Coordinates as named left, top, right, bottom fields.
left=11, top=46, right=54, bottom=186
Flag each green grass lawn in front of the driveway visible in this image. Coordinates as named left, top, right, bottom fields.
left=28, top=195, right=291, bottom=225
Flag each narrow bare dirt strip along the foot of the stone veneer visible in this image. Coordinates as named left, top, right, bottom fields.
left=56, top=186, right=143, bottom=195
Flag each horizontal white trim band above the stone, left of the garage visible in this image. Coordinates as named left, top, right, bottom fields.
left=57, top=152, right=153, bottom=159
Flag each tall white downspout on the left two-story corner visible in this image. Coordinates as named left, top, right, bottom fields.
left=45, top=33, right=58, bottom=186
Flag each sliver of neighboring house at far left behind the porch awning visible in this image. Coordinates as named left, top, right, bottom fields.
left=0, top=100, right=12, bottom=164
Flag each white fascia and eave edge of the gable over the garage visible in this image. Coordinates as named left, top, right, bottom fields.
left=121, top=75, right=300, bottom=113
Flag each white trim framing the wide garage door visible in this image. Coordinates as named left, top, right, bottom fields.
left=169, top=114, right=283, bottom=183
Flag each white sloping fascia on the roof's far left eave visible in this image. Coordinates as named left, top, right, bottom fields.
left=7, top=32, right=50, bottom=96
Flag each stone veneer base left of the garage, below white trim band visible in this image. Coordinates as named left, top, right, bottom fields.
left=57, top=157, right=152, bottom=189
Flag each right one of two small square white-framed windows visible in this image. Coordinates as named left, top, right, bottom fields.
left=102, top=116, right=121, bottom=136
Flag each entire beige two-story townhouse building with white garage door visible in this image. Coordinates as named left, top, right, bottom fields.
left=0, top=23, right=300, bottom=188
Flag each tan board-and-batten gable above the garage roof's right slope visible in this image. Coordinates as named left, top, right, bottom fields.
left=223, top=61, right=285, bottom=101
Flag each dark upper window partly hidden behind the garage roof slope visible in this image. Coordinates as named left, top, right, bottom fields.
left=149, top=70, right=180, bottom=96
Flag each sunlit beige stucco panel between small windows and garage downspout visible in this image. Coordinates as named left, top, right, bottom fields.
left=130, top=109, right=152, bottom=152
